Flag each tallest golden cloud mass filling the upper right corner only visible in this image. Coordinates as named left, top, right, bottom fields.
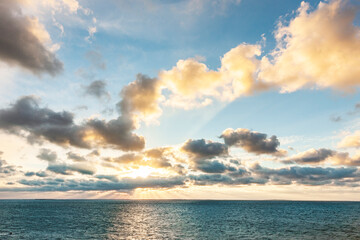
left=258, top=0, right=360, bottom=92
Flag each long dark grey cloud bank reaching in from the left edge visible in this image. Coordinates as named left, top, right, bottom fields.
left=0, top=96, right=145, bottom=151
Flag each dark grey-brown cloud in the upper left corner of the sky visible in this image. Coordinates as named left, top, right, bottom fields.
left=0, top=0, right=63, bottom=76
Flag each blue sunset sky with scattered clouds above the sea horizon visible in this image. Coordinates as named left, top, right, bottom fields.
left=0, top=0, right=360, bottom=201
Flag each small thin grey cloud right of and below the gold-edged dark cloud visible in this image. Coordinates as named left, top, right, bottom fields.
left=283, top=148, right=337, bottom=164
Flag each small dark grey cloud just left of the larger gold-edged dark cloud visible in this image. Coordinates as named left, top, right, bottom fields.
left=182, top=139, right=228, bottom=158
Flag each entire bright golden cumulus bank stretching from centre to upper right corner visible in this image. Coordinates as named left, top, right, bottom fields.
left=159, top=0, right=360, bottom=109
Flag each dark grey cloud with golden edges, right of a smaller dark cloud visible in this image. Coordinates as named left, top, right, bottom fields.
left=220, top=128, right=286, bottom=156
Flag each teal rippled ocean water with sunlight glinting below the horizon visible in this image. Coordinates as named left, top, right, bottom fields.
left=0, top=200, right=360, bottom=240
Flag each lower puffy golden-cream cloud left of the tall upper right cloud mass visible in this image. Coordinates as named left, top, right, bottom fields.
left=159, top=44, right=267, bottom=109
